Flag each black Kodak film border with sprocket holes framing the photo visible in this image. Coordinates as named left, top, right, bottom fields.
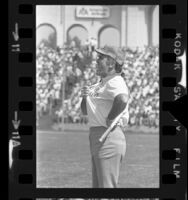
left=8, top=0, right=187, bottom=200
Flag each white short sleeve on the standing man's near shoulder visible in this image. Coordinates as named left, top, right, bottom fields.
left=106, top=77, right=129, bottom=99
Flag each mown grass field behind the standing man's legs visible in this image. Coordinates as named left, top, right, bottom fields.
left=37, top=126, right=159, bottom=188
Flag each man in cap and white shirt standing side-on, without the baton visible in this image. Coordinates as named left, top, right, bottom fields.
left=81, top=46, right=129, bottom=188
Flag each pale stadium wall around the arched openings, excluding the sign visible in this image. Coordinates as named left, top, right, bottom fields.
left=36, top=5, right=159, bottom=47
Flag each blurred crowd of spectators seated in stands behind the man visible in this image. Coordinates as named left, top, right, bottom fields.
left=36, top=40, right=159, bottom=127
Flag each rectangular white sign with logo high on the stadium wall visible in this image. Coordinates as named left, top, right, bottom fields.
left=76, top=6, right=110, bottom=18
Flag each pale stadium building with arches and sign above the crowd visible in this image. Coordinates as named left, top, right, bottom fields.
left=36, top=5, right=159, bottom=47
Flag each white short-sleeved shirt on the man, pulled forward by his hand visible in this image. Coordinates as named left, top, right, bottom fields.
left=86, top=74, right=129, bottom=127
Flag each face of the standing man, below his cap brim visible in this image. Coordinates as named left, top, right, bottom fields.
left=96, top=54, right=113, bottom=78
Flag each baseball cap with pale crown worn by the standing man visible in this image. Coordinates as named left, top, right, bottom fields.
left=95, top=45, right=125, bottom=65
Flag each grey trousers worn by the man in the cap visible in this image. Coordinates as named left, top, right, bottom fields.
left=89, top=126, right=126, bottom=188
